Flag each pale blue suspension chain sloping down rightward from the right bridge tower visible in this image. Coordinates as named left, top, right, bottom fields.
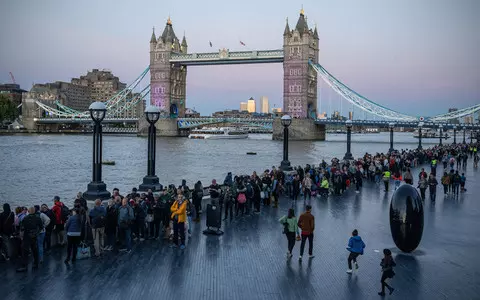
left=309, top=61, right=418, bottom=121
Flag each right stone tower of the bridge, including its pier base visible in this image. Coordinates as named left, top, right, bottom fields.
left=273, top=9, right=325, bottom=140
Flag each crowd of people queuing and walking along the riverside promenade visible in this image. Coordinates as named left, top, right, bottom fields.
left=0, top=144, right=479, bottom=294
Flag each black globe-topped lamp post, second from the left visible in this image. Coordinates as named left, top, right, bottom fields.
left=138, top=106, right=162, bottom=191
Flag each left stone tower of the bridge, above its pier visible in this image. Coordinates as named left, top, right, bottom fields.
left=150, top=17, right=188, bottom=117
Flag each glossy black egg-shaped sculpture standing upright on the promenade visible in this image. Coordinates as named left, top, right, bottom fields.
left=390, top=184, right=423, bottom=252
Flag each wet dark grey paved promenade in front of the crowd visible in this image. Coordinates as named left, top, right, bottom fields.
left=0, top=164, right=480, bottom=300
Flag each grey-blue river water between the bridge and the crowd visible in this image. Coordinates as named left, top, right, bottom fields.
left=0, top=133, right=438, bottom=206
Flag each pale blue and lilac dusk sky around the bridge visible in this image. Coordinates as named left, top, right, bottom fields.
left=0, top=0, right=480, bottom=115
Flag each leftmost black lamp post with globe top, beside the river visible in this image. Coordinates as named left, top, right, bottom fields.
left=83, top=101, right=110, bottom=200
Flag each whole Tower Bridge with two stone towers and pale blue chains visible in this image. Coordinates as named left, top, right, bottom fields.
left=22, top=9, right=480, bottom=140
